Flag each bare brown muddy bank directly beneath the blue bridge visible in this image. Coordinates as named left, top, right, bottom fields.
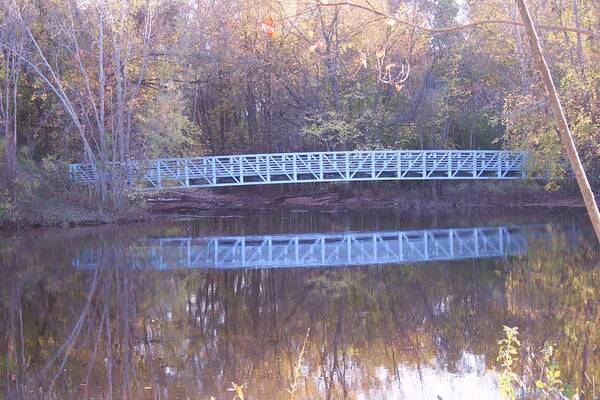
left=146, top=183, right=584, bottom=214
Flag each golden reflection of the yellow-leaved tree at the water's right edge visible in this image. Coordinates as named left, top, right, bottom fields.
left=506, top=230, right=600, bottom=399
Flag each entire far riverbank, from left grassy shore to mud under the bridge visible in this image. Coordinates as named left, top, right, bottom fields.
left=0, top=182, right=584, bottom=232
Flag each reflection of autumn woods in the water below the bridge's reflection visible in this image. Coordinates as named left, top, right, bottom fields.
left=0, top=228, right=599, bottom=398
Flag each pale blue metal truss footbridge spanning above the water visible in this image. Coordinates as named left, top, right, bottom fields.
left=69, top=150, right=526, bottom=191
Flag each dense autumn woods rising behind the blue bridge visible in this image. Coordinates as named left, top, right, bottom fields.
left=0, top=0, right=600, bottom=198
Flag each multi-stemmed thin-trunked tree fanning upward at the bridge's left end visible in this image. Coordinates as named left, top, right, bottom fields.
left=11, top=0, right=172, bottom=199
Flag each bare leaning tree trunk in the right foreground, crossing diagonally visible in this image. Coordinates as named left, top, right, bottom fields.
left=516, top=0, right=600, bottom=241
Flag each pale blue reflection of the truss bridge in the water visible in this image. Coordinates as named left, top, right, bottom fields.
left=73, top=225, right=548, bottom=270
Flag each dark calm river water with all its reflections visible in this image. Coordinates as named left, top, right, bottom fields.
left=0, top=209, right=600, bottom=399
